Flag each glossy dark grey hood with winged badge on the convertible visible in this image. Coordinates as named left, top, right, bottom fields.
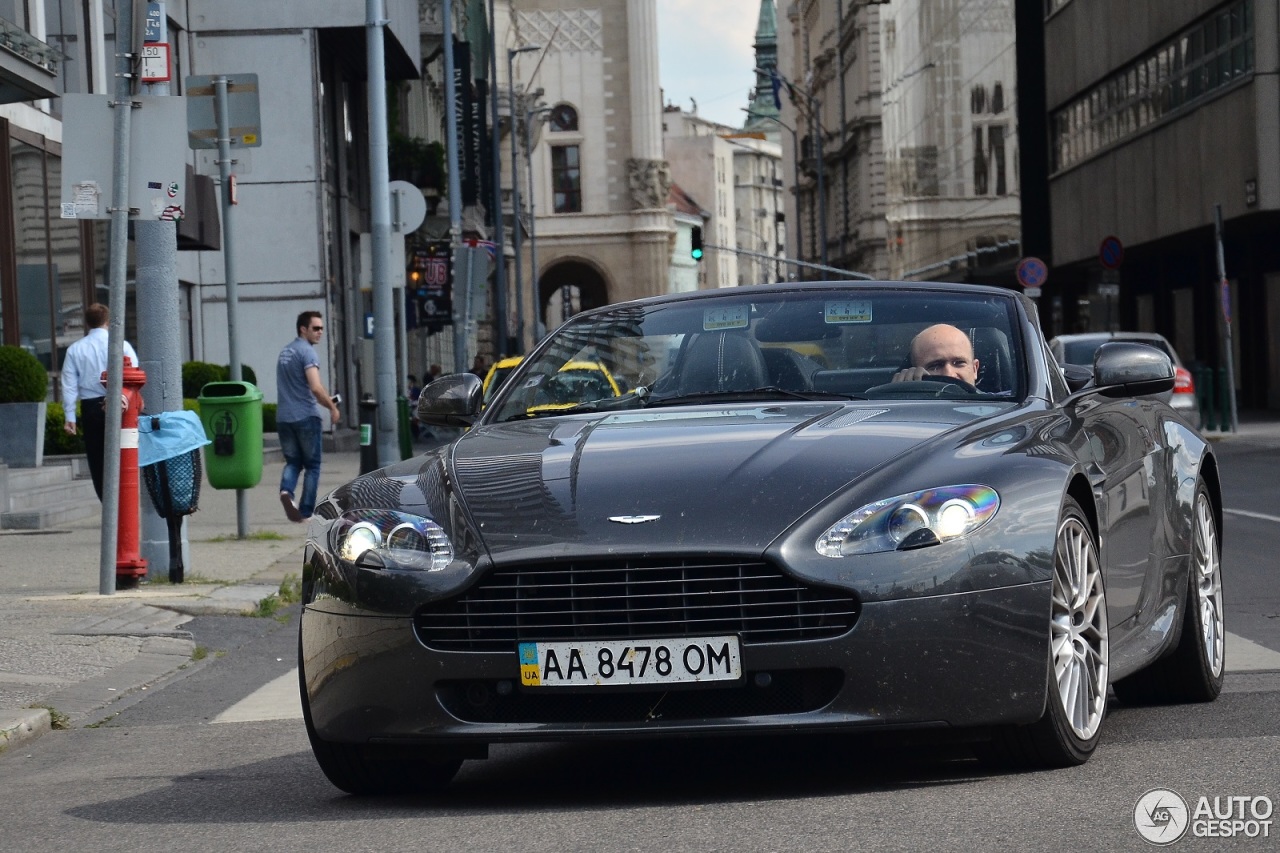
left=440, top=402, right=1009, bottom=560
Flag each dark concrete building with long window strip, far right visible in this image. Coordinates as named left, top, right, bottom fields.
left=1038, top=0, right=1280, bottom=409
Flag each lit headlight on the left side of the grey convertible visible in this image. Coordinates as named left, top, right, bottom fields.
left=329, top=510, right=453, bottom=571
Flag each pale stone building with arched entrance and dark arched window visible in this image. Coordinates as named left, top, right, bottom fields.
left=495, top=0, right=676, bottom=343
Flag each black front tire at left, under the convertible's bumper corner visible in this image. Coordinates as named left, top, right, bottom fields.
left=298, top=631, right=462, bottom=797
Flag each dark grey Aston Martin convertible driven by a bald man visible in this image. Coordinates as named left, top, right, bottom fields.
left=300, top=282, right=1225, bottom=793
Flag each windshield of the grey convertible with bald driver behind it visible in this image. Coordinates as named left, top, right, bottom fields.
left=490, top=287, right=1027, bottom=420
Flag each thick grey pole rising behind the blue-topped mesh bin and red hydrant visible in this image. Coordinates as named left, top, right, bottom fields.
left=133, top=0, right=186, bottom=567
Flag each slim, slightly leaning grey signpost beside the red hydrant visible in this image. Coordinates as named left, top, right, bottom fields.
left=97, top=1, right=133, bottom=596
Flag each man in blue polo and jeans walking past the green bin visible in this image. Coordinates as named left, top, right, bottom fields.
left=275, top=311, right=342, bottom=521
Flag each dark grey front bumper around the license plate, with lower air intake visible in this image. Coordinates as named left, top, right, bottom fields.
left=301, top=581, right=1050, bottom=743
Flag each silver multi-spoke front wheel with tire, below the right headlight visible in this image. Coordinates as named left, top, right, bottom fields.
left=975, top=497, right=1110, bottom=767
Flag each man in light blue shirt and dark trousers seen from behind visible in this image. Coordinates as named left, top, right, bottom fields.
left=60, top=302, right=138, bottom=501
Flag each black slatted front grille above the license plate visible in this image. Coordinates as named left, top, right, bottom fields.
left=413, top=560, right=859, bottom=652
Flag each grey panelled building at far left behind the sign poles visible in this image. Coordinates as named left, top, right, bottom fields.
left=0, top=0, right=420, bottom=423
